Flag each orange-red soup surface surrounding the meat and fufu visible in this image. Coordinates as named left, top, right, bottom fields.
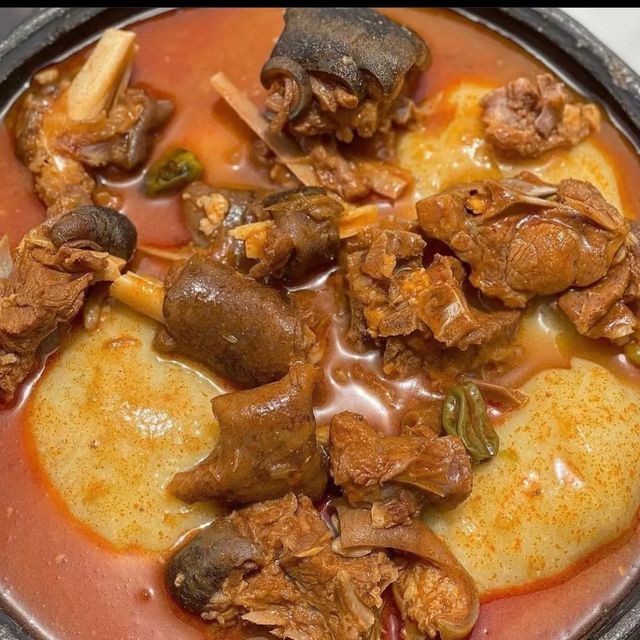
left=0, top=9, right=640, bottom=640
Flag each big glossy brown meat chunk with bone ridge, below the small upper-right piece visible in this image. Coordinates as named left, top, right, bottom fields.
left=417, top=173, right=627, bottom=308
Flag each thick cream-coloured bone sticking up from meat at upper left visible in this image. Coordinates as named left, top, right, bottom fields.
left=67, top=29, right=136, bottom=122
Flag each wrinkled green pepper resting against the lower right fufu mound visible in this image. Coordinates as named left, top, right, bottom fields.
left=442, top=382, right=500, bottom=462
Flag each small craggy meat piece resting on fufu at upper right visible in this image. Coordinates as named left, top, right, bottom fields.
left=480, top=73, right=600, bottom=158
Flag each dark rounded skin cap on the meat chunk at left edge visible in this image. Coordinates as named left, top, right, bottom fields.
left=50, top=205, right=138, bottom=260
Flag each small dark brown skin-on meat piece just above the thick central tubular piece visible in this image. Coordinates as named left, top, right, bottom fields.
left=249, top=187, right=343, bottom=282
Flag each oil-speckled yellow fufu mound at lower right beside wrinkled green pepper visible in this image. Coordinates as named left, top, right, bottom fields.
left=427, top=358, right=640, bottom=594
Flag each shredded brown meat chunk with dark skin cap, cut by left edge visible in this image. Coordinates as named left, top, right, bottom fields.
left=0, top=207, right=136, bottom=404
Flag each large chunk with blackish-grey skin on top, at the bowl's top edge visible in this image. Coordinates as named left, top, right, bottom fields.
left=261, top=8, right=429, bottom=142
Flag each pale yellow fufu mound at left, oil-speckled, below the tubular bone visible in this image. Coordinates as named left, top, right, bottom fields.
left=28, top=305, right=220, bottom=551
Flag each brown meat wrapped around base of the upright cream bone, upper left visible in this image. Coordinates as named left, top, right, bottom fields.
left=10, top=73, right=173, bottom=216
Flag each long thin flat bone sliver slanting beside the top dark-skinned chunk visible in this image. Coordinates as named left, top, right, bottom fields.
left=211, top=72, right=320, bottom=187
